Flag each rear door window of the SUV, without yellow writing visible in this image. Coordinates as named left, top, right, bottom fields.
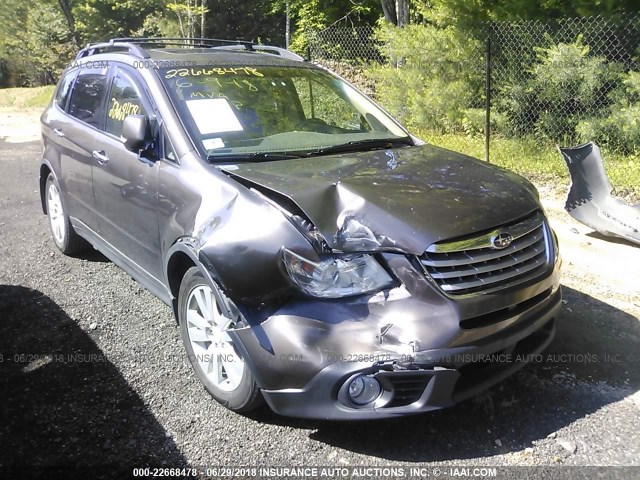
left=69, top=73, right=107, bottom=128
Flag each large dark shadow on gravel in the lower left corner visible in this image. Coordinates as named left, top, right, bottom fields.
left=0, top=285, right=186, bottom=470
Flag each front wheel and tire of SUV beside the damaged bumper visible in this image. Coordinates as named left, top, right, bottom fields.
left=178, top=267, right=263, bottom=412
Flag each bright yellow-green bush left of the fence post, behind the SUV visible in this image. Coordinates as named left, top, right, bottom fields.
left=369, top=20, right=484, bottom=132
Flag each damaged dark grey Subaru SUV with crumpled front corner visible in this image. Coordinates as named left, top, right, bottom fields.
left=40, top=39, right=561, bottom=419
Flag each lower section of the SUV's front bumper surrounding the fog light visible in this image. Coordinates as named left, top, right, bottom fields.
left=262, top=291, right=561, bottom=420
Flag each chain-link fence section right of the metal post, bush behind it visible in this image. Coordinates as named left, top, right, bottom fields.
left=488, top=14, right=640, bottom=153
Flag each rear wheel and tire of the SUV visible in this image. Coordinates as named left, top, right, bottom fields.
left=44, top=173, right=88, bottom=255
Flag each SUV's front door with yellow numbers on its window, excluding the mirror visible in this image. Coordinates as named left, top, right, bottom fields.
left=93, top=66, right=162, bottom=280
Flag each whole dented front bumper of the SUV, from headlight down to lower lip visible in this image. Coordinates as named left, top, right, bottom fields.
left=230, top=255, right=561, bottom=420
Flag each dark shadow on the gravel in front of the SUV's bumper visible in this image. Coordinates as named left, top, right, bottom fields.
left=249, top=287, right=640, bottom=462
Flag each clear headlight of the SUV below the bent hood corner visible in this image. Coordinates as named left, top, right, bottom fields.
left=282, top=248, right=393, bottom=298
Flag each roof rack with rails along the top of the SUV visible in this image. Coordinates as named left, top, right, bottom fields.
left=76, top=37, right=304, bottom=61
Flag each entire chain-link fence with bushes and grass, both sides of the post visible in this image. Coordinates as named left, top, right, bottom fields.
left=307, top=13, right=640, bottom=197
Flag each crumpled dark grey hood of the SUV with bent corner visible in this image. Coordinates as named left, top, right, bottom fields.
left=219, top=145, right=540, bottom=255
